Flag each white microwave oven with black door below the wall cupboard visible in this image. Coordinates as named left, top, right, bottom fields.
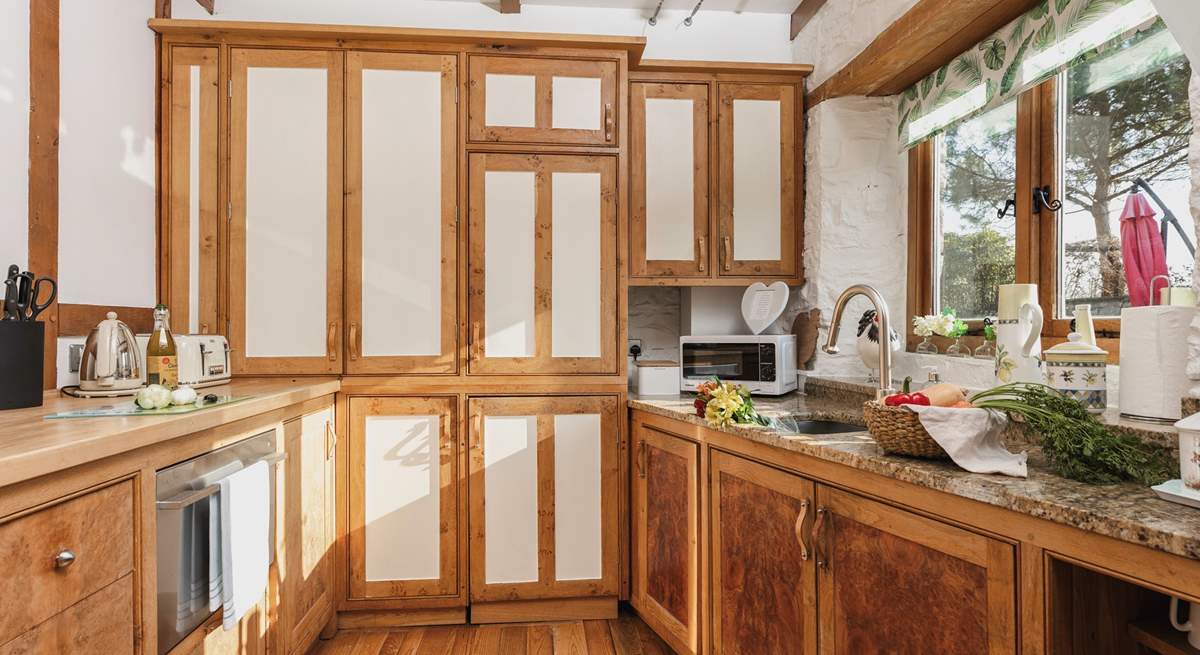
left=679, top=335, right=797, bottom=396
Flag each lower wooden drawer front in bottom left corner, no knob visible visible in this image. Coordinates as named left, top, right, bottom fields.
left=0, top=575, right=134, bottom=655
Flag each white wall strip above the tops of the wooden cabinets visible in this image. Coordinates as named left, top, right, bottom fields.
left=174, top=0, right=796, bottom=62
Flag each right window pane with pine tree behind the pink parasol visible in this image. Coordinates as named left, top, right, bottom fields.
left=1058, top=20, right=1195, bottom=316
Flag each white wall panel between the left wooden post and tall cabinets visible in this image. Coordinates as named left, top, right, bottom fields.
left=59, top=0, right=158, bottom=307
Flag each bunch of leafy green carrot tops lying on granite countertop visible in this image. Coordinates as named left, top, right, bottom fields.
left=971, top=383, right=1175, bottom=485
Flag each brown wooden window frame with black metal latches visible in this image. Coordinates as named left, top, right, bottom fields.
left=904, top=77, right=1121, bottom=363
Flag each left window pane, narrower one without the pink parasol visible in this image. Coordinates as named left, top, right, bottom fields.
left=934, top=101, right=1016, bottom=318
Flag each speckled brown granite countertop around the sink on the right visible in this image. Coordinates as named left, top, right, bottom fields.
left=629, top=380, right=1200, bottom=559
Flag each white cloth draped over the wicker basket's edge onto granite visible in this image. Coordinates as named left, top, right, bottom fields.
left=905, top=404, right=1030, bottom=477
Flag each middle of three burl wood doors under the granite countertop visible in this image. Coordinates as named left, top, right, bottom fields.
left=709, top=451, right=817, bottom=655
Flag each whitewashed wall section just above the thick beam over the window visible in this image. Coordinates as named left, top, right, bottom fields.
left=792, top=0, right=917, bottom=89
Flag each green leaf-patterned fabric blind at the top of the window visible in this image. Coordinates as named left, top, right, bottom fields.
left=898, top=0, right=1158, bottom=150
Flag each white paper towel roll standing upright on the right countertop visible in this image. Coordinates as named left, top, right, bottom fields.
left=1118, top=305, right=1196, bottom=420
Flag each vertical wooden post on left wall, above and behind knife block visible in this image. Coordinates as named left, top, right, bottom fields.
left=29, top=0, right=59, bottom=389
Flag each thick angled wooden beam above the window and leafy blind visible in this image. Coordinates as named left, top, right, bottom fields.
left=808, top=0, right=1039, bottom=107
